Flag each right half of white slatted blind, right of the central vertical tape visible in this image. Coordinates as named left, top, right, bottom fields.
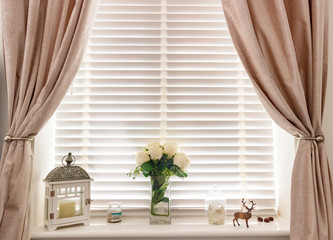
left=167, top=0, right=275, bottom=213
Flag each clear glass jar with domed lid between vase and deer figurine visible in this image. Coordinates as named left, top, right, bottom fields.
left=205, top=185, right=226, bottom=225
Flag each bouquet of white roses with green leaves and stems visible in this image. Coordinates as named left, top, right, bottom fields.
left=128, top=142, right=190, bottom=220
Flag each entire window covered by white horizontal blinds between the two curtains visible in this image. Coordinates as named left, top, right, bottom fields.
left=55, top=0, right=276, bottom=214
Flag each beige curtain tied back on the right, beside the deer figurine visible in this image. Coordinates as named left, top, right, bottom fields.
left=222, top=0, right=333, bottom=240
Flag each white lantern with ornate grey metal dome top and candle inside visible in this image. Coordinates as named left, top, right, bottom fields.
left=44, top=153, right=93, bottom=231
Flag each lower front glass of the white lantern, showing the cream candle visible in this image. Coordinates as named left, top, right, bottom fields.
left=57, top=196, right=84, bottom=219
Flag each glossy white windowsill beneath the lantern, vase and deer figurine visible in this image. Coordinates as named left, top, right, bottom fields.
left=31, top=217, right=289, bottom=240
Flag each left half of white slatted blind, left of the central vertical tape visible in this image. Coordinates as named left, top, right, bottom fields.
left=56, top=0, right=161, bottom=210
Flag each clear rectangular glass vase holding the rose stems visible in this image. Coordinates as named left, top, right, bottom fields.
left=149, top=175, right=171, bottom=225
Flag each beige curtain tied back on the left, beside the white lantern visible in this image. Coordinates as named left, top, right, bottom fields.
left=0, top=0, right=97, bottom=240
